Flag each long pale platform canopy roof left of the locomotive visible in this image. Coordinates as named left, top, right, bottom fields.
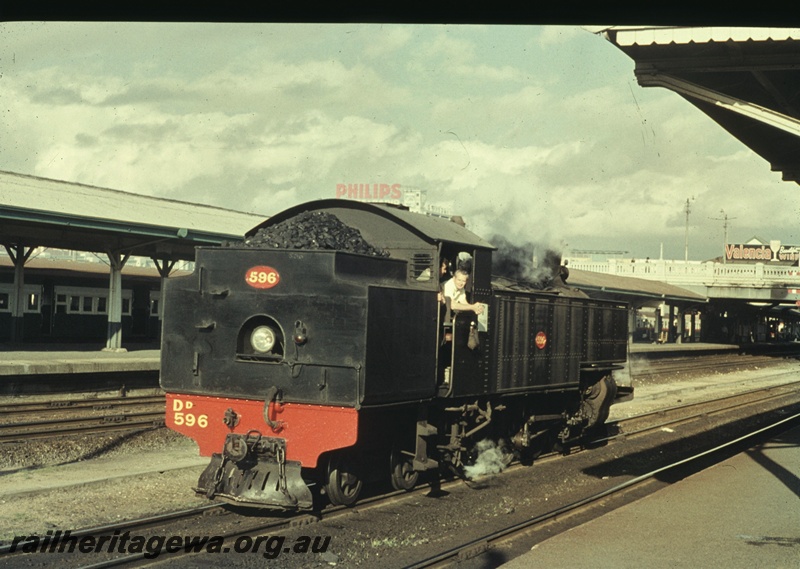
left=0, top=171, right=267, bottom=261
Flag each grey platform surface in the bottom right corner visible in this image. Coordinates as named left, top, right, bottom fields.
left=502, top=427, right=800, bottom=569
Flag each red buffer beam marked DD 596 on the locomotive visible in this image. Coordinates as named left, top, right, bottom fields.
left=166, top=393, right=358, bottom=468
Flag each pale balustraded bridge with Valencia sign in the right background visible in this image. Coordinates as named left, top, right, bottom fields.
left=567, top=238, right=800, bottom=344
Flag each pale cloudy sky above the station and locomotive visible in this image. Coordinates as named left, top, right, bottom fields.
left=0, top=22, right=800, bottom=260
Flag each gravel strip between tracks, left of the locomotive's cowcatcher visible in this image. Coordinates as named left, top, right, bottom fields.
left=0, top=429, right=208, bottom=543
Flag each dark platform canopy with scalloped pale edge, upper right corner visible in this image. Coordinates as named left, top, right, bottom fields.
left=585, top=26, right=800, bottom=183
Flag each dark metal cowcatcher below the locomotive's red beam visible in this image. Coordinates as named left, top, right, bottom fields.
left=195, top=432, right=313, bottom=510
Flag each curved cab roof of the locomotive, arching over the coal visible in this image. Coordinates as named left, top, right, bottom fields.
left=246, top=198, right=495, bottom=249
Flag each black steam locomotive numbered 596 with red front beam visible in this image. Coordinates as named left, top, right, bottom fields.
left=161, top=199, right=632, bottom=510
